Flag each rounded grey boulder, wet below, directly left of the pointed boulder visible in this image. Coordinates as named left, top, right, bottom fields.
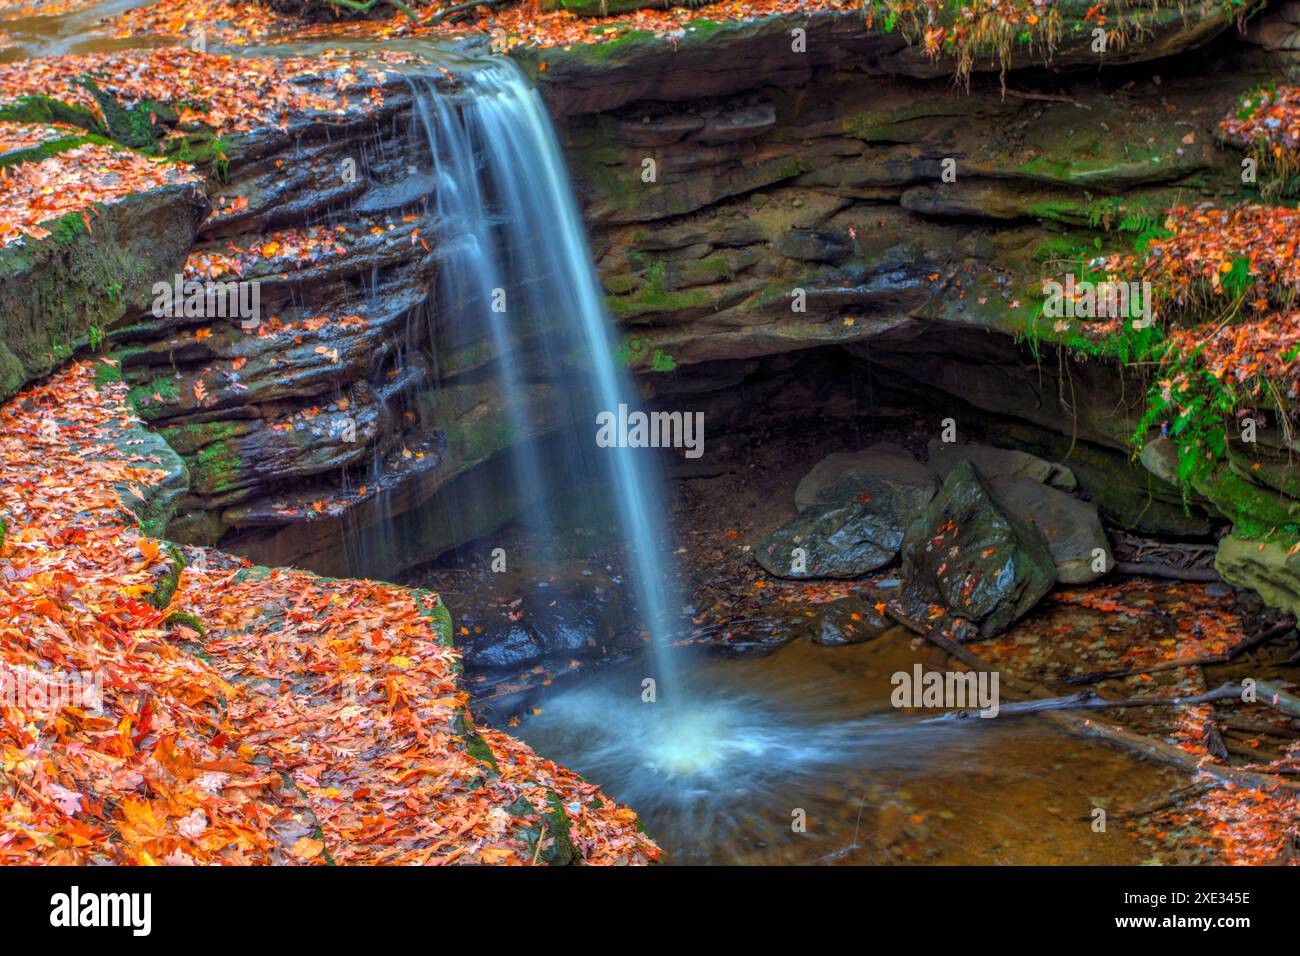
left=757, top=446, right=937, bottom=580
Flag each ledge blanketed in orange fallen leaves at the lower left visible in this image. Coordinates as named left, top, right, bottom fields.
left=0, top=364, right=658, bottom=864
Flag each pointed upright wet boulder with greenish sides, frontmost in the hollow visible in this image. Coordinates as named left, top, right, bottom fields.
left=900, top=462, right=1056, bottom=639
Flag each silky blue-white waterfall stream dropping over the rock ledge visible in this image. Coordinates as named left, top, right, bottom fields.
left=411, top=57, right=675, bottom=691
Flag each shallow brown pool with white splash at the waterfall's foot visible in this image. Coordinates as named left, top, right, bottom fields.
left=517, top=631, right=1179, bottom=864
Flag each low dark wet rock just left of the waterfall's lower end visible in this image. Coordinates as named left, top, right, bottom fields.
left=458, top=567, right=638, bottom=671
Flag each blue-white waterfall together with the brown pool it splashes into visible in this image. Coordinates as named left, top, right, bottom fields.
left=387, top=59, right=1190, bottom=862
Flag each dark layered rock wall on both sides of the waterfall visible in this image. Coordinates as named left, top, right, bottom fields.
left=12, top=7, right=1292, bottom=608
